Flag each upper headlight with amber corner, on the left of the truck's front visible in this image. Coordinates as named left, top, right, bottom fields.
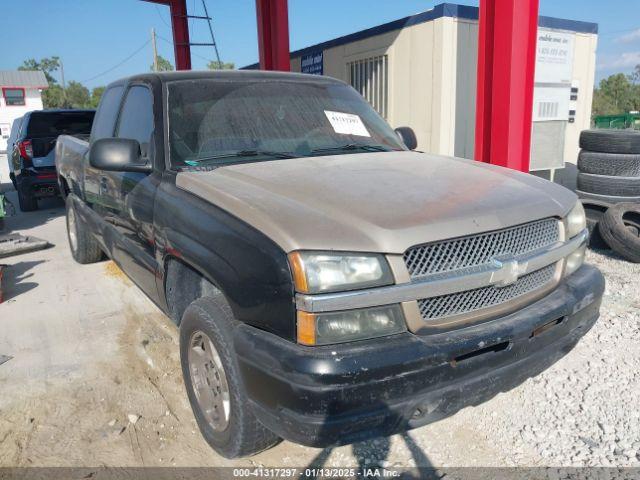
left=289, top=252, right=393, bottom=293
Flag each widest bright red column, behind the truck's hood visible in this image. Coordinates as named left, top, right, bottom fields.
left=475, top=0, right=538, bottom=172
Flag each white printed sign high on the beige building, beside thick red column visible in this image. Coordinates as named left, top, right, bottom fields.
left=536, top=28, right=575, bottom=84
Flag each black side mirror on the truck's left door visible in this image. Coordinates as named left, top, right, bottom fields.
left=89, top=138, right=152, bottom=173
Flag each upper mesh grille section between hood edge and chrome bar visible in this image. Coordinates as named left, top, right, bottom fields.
left=404, top=218, right=560, bottom=279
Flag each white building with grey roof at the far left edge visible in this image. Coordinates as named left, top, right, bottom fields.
left=0, top=70, right=48, bottom=182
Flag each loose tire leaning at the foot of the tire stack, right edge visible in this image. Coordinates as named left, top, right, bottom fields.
left=600, top=203, right=640, bottom=263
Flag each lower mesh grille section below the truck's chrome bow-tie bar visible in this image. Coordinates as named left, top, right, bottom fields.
left=418, top=263, right=556, bottom=320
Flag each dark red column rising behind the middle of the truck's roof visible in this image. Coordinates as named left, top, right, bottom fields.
left=256, top=0, right=291, bottom=72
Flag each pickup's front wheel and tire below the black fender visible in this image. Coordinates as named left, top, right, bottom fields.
left=180, top=293, right=280, bottom=458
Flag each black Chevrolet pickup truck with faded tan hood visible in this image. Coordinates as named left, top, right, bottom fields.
left=56, top=71, right=604, bottom=458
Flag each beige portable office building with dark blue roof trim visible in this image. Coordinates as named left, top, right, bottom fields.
left=248, top=4, right=598, bottom=175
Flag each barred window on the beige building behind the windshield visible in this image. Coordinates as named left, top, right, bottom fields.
left=347, top=55, right=389, bottom=118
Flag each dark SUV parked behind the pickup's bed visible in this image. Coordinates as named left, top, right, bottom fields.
left=8, top=110, right=95, bottom=212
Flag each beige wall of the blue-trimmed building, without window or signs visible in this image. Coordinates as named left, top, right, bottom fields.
left=292, top=17, right=597, bottom=169
